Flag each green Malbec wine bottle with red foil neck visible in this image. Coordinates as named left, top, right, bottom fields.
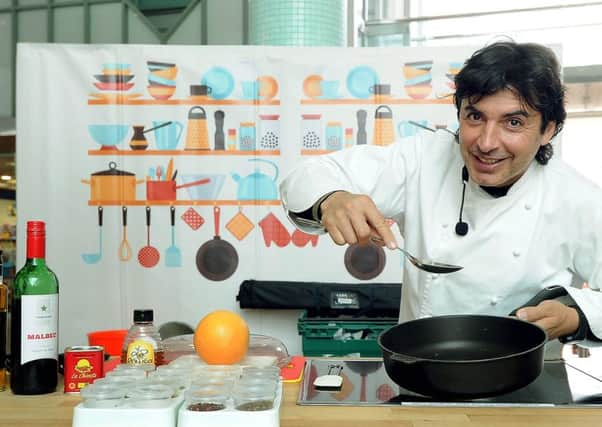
left=10, top=221, right=59, bottom=394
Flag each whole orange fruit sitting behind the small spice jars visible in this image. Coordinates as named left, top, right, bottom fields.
left=193, top=310, right=249, bottom=365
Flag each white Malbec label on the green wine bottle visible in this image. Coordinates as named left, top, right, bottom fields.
left=21, top=294, right=59, bottom=364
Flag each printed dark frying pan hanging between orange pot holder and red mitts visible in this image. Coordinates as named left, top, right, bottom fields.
left=196, top=206, right=238, bottom=282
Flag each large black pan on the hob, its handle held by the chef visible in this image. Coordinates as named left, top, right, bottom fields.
left=378, top=286, right=567, bottom=400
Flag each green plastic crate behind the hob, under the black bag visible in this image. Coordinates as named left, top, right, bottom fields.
left=297, top=311, right=397, bottom=357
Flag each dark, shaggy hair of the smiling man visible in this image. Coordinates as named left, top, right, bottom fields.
left=454, top=41, right=566, bottom=165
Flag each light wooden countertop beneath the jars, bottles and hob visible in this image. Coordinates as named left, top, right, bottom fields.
left=0, top=383, right=602, bottom=427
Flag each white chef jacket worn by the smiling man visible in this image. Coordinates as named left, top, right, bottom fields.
left=280, top=131, right=602, bottom=339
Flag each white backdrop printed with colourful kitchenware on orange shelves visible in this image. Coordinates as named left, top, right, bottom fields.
left=17, top=44, right=510, bottom=353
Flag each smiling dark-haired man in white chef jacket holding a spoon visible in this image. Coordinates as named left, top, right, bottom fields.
left=280, top=41, right=602, bottom=343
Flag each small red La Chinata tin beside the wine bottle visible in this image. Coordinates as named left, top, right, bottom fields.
left=64, top=345, right=104, bottom=393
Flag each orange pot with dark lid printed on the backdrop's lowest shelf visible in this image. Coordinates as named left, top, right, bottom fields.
left=81, top=162, right=144, bottom=203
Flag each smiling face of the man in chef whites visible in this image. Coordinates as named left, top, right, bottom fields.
left=459, top=89, right=555, bottom=187
